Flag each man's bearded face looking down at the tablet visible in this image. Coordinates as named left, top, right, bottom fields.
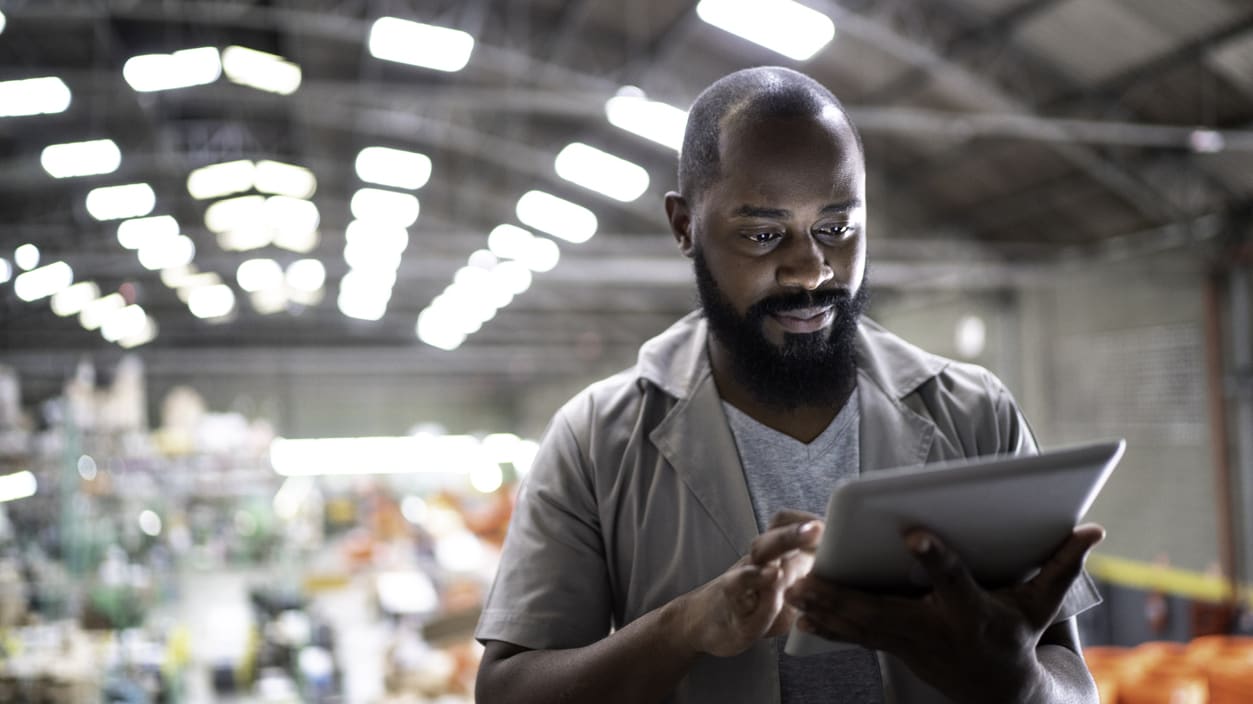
left=690, top=108, right=866, bottom=407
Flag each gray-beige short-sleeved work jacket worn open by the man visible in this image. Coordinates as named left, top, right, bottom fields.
left=475, top=313, right=1099, bottom=704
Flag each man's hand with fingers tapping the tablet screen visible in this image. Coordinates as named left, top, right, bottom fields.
left=673, top=511, right=823, bottom=656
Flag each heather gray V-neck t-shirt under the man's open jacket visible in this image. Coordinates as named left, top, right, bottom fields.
left=723, top=392, right=883, bottom=704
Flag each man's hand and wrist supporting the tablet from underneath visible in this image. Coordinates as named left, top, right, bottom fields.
left=786, top=524, right=1105, bottom=703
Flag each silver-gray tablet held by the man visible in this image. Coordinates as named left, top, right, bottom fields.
left=784, top=440, right=1126, bottom=655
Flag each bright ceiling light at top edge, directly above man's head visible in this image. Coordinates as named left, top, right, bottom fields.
left=697, top=0, right=836, bottom=61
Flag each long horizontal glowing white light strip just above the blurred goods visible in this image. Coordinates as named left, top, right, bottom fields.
left=269, top=435, right=491, bottom=477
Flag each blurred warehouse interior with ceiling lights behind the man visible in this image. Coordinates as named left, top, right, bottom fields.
left=0, top=0, right=1253, bottom=704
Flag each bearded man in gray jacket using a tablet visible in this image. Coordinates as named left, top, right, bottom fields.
left=476, top=68, right=1101, bottom=704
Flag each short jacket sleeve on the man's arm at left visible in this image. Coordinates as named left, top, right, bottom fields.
left=475, top=413, right=611, bottom=650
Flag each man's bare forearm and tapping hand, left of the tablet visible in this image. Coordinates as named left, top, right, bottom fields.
left=475, top=513, right=821, bottom=704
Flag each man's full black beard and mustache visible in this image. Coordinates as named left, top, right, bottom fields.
left=693, top=247, right=870, bottom=411
